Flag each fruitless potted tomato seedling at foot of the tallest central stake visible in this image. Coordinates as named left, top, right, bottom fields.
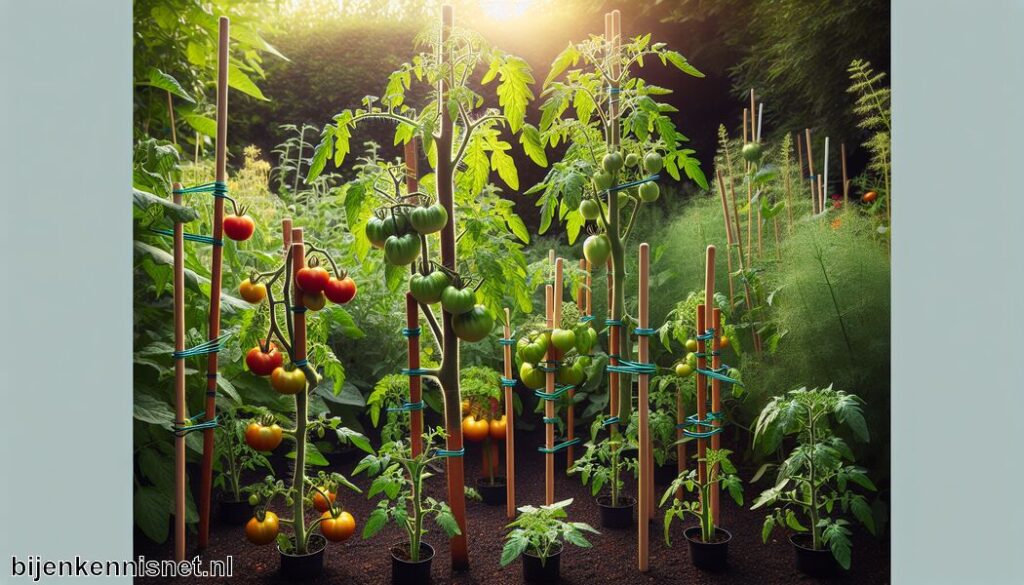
left=352, top=427, right=460, bottom=585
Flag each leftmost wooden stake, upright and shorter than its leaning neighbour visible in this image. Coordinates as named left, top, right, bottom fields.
left=172, top=182, right=188, bottom=562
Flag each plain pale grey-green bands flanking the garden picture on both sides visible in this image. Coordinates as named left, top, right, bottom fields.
left=0, top=0, right=1024, bottom=585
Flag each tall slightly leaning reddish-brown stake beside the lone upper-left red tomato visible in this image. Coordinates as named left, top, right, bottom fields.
left=199, top=16, right=230, bottom=549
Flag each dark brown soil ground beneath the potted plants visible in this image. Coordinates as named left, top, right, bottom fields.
left=135, top=430, right=890, bottom=585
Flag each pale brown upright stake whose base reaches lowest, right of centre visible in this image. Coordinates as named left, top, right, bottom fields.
left=634, top=243, right=653, bottom=573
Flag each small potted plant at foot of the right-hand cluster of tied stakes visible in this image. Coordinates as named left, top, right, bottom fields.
left=660, top=449, right=743, bottom=571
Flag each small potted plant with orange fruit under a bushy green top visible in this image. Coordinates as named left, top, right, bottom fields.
left=461, top=366, right=507, bottom=506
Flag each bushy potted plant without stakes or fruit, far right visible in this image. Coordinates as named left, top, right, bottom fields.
left=752, top=385, right=876, bottom=576
